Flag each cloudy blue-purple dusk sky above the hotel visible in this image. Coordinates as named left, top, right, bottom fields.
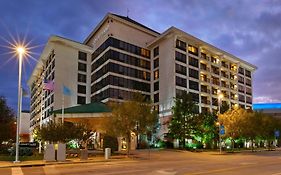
left=0, top=0, right=281, bottom=111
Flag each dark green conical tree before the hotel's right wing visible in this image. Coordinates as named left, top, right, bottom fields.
left=169, top=92, right=200, bottom=148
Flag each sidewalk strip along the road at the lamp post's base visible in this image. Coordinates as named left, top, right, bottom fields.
left=0, top=156, right=128, bottom=168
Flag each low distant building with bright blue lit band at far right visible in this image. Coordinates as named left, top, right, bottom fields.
left=253, top=103, right=281, bottom=118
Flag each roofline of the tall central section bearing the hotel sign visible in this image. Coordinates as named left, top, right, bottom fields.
left=83, top=13, right=160, bottom=44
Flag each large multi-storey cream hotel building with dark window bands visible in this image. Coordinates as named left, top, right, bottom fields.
left=29, top=14, right=256, bottom=139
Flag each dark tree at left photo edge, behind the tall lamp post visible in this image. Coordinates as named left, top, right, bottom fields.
left=0, top=96, right=16, bottom=146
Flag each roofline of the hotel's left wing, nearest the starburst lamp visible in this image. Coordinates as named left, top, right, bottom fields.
left=27, top=35, right=93, bottom=85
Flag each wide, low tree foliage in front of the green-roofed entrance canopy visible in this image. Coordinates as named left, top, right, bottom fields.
left=36, top=121, right=88, bottom=143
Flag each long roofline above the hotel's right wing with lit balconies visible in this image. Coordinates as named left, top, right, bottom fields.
left=147, top=26, right=257, bottom=70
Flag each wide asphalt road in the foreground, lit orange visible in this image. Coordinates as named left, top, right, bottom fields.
left=0, top=151, right=281, bottom=175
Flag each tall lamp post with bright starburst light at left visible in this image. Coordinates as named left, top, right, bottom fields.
left=14, top=46, right=25, bottom=163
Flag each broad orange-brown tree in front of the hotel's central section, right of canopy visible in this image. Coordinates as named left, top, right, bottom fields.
left=104, top=93, right=157, bottom=155
